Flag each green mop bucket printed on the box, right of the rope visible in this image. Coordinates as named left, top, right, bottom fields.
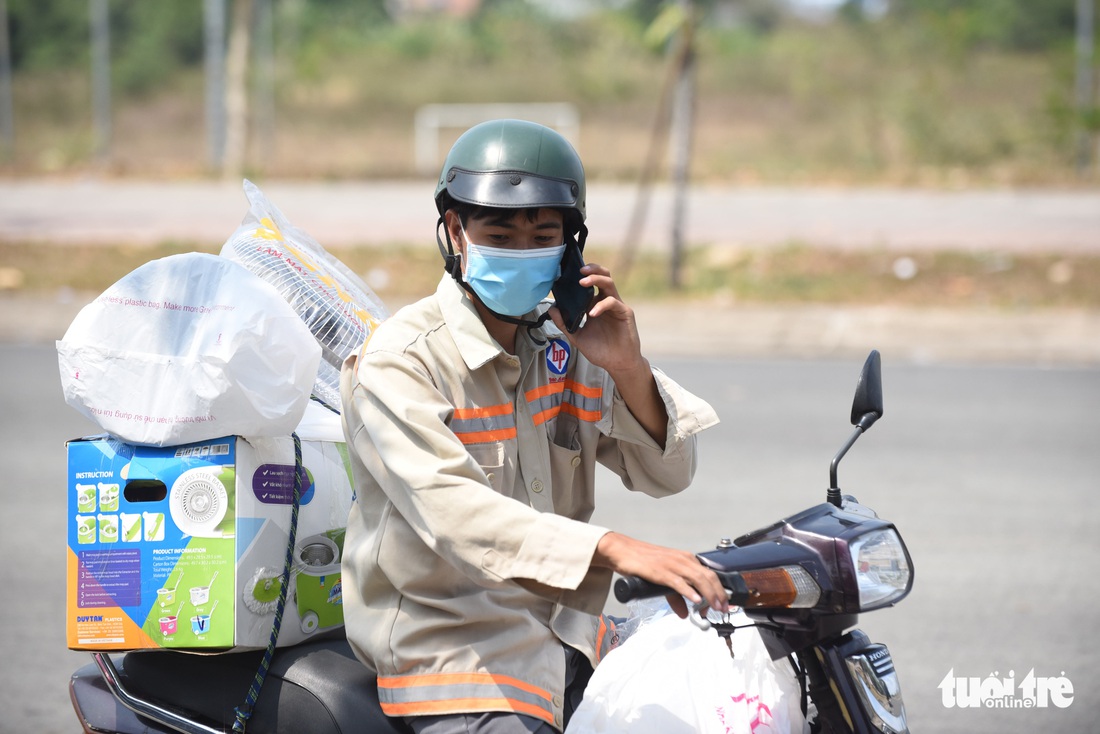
left=294, top=534, right=343, bottom=634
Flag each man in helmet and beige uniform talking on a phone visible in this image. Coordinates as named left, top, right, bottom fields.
left=341, top=120, right=728, bottom=734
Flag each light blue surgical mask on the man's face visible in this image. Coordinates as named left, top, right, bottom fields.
left=463, top=238, right=565, bottom=316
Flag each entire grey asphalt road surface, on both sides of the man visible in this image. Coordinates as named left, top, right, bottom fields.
left=0, top=344, right=1100, bottom=734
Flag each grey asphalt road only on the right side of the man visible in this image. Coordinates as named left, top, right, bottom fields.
left=595, top=359, right=1100, bottom=734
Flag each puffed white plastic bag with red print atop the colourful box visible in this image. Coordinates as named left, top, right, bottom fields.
left=57, top=253, right=321, bottom=446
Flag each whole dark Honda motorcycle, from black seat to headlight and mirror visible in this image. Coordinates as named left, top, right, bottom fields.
left=69, top=351, right=913, bottom=734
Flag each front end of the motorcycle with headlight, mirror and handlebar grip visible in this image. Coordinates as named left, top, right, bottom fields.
left=615, top=351, right=913, bottom=734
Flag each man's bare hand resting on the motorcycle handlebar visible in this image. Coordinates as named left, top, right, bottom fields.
left=592, top=532, right=729, bottom=618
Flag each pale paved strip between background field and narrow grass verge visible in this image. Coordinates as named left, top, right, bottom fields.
left=0, top=179, right=1100, bottom=253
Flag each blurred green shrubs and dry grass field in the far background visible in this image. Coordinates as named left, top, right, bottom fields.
left=0, top=0, right=1100, bottom=187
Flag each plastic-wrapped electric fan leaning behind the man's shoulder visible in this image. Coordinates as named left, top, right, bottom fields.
left=221, top=179, right=389, bottom=410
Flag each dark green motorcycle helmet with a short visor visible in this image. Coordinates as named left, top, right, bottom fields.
left=436, top=120, right=585, bottom=227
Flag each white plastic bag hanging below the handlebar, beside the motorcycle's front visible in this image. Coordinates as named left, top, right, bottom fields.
left=565, top=613, right=809, bottom=734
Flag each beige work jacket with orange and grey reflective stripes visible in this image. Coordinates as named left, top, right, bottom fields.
left=341, top=276, right=717, bottom=728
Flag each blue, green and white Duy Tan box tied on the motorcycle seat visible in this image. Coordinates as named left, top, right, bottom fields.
left=66, top=406, right=352, bottom=650
